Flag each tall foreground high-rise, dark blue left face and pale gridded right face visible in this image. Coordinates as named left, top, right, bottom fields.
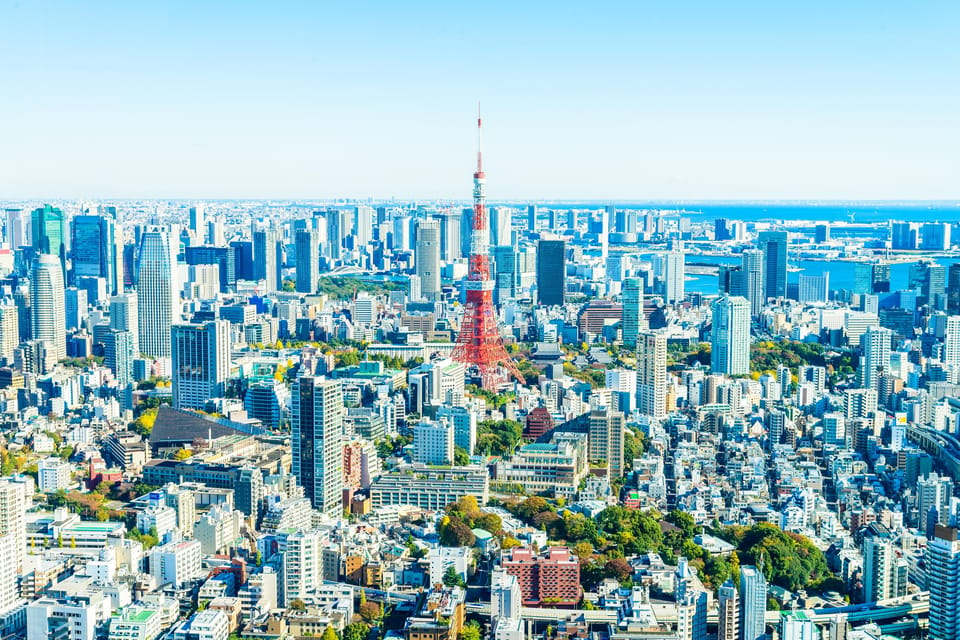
left=291, top=376, right=344, bottom=516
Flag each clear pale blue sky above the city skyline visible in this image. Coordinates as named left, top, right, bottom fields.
left=0, top=0, right=960, bottom=199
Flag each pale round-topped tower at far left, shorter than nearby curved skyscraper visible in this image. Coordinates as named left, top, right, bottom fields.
left=30, top=253, right=67, bottom=360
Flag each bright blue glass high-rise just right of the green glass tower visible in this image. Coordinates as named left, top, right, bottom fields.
left=70, top=215, right=123, bottom=295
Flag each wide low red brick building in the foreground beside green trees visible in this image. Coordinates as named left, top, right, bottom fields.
left=502, top=547, right=580, bottom=607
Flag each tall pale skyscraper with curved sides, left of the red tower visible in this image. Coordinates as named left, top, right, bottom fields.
left=137, top=227, right=180, bottom=358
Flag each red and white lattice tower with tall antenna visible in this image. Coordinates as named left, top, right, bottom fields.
left=453, top=112, right=523, bottom=391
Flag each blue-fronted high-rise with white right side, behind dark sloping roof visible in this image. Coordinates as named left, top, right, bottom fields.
left=171, top=320, right=230, bottom=409
